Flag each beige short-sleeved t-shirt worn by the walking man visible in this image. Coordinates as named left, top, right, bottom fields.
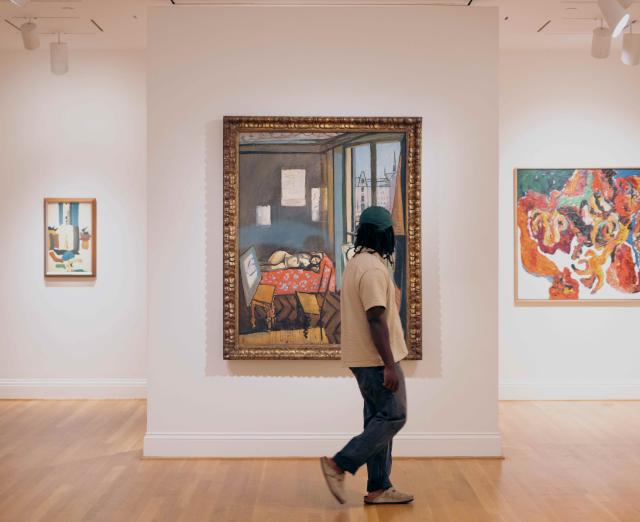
left=340, top=251, right=409, bottom=367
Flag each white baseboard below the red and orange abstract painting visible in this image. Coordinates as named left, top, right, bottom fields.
left=500, top=382, right=640, bottom=401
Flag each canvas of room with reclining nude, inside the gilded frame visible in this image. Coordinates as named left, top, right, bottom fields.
left=222, top=118, right=422, bottom=358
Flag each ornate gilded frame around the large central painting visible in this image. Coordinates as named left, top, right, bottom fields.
left=223, top=116, right=422, bottom=360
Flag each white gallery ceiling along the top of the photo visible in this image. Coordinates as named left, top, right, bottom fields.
left=0, top=0, right=640, bottom=50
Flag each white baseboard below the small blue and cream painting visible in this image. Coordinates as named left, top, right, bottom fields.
left=0, top=379, right=147, bottom=399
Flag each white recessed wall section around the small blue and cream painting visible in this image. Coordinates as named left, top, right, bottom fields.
left=0, top=51, right=147, bottom=398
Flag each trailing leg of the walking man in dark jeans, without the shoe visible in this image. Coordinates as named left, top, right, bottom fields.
left=333, top=365, right=407, bottom=474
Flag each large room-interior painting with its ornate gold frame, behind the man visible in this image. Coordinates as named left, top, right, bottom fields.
left=223, top=116, right=422, bottom=359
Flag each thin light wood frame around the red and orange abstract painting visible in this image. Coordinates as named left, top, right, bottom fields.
left=512, top=167, right=640, bottom=307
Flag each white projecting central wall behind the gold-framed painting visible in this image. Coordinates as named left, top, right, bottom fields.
left=145, top=6, right=500, bottom=456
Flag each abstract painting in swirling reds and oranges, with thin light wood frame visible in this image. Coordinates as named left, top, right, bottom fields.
left=514, top=168, right=640, bottom=306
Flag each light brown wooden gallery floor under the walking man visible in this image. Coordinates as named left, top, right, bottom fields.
left=0, top=401, right=640, bottom=522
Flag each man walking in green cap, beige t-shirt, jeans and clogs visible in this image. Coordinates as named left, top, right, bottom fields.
left=320, top=206, right=413, bottom=504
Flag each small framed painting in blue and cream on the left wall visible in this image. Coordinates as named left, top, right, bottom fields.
left=44, top=198, right=96, bottom=278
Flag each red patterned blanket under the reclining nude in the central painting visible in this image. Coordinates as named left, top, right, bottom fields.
left=260, top=255, right=336, bottom=295
